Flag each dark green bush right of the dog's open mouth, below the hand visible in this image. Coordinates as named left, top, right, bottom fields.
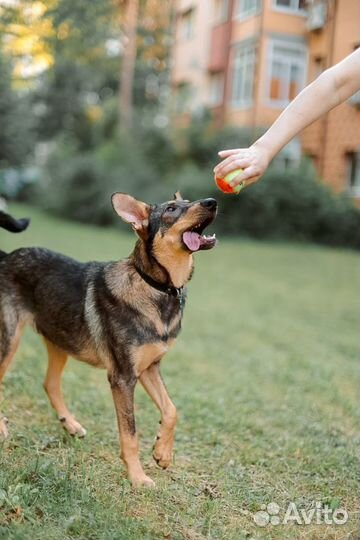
left=173, top=161, right=360, bottom=249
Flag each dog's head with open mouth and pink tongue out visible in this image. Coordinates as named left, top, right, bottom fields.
left=112, top=192, right=217, bottom=281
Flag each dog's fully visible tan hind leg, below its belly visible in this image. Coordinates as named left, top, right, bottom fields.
left=44, top=339, right=86, bottom=437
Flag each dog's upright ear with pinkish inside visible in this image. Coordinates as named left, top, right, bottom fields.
left=111, top=193, right=150, bottom=233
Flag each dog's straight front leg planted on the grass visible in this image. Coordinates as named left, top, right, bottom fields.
left=109, top=374, right=155, bottom=487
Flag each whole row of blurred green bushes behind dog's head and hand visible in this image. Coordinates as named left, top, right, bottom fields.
left=33, top=112, right=360, bottom=248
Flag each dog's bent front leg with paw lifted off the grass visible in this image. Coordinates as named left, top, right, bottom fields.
left=140, top=362, right=176, bottom=469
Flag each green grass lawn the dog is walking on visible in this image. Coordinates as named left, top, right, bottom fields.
left=0, top=205, right=360, bottom=540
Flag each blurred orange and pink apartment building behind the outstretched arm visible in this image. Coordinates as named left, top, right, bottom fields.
left=172, top=0, right=360, bottom=201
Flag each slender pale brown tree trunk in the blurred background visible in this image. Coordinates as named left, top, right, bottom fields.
left=119, top=0, right=139, bottom=130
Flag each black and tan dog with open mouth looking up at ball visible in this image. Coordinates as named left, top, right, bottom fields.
left=0, top=192, right=217, bottom=487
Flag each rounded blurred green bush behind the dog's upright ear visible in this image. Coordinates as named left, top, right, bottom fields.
left=32, top=133, right=169, bottom=225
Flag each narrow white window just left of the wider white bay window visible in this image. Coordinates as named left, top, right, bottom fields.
left=232, top=45, right=256, bottom=107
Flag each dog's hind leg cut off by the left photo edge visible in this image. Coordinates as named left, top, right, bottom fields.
left=0, top=320, right=21, bottom=439
